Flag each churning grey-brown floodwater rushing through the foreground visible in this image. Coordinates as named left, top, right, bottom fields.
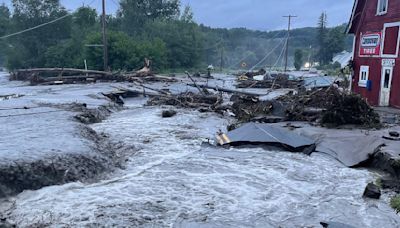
left=2, top=95, right=400, bottom=227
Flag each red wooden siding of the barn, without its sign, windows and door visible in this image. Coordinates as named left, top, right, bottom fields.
left=349, top=0, right=400, bottom=108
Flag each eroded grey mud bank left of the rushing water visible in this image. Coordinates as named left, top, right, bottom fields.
left=0, top=75, right=136, bottom=198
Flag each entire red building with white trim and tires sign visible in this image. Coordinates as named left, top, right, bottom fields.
left=348, top=0, right=400, bottom=108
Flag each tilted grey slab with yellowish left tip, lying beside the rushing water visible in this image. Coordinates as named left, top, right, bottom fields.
left=217, top=123, right=315, bottom=154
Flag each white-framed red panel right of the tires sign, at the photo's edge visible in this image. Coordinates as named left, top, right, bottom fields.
left=382, top=24, right=400, bottom=57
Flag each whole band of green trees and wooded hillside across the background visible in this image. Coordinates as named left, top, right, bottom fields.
left=0, top=0, right=352, bottom=70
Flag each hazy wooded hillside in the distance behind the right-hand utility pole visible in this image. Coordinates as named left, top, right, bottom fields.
left=200, top=24, right=353, bottom=68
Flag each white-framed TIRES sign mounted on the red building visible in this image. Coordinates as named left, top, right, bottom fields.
left=360, top=32, right=382, bottom=56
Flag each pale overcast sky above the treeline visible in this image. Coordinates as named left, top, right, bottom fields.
left=0, top=0, right=353, bottom=30
